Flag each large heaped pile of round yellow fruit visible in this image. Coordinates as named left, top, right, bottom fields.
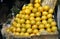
left=6, top=0, right=57, bottom=36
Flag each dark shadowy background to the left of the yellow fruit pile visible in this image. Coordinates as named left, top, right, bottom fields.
left=0, top=0, right=29, bottom=39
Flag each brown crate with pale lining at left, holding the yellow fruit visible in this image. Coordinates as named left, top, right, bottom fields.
left=1, top=24, right=58, bottom=39
